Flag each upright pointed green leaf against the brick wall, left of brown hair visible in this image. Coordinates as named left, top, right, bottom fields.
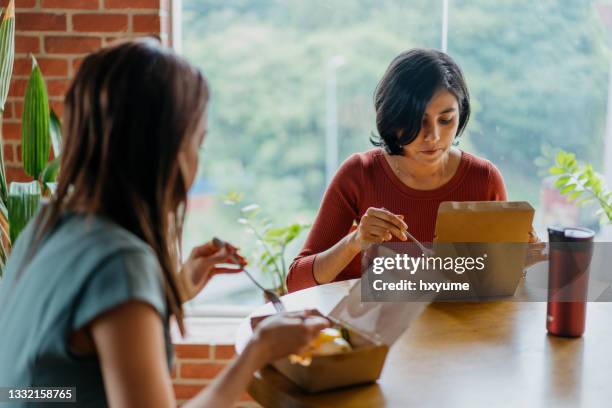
left=21, top=56, right=51, bottom=180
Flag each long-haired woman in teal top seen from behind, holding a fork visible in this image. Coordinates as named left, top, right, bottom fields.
left=0, top=40, right=327, bottom=407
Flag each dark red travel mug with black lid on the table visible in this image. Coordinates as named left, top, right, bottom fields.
left=546, top=227, right=595, bottom=337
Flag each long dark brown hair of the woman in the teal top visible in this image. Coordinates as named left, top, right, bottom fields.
left=35, top=39, right=209, bottom=331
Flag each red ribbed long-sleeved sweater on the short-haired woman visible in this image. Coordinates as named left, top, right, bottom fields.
left=287, top=149, right=506, bottom=292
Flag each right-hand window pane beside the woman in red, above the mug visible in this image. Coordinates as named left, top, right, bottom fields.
left=448, top=0, right=609, bottom=236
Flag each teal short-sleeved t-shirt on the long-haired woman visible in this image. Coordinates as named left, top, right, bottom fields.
left=0, top=213, right=172, bottom=407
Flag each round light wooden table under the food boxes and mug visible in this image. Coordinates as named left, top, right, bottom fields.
left=236, top=282, right=612, bottom=408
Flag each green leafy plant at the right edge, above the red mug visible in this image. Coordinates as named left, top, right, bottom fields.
left=548, top=150, right=612, bottom=224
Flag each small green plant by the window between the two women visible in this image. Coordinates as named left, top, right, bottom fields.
left=223, top=193, right=310, bottom=295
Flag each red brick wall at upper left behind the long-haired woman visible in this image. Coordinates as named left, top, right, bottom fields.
left=0, top=0, right=170, bottom=182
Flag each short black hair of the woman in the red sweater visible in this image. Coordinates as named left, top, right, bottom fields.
left=370, top=48, right=470, bottom=155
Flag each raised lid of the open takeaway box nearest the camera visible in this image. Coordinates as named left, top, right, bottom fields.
left=329, top=280, right=431, bottom=346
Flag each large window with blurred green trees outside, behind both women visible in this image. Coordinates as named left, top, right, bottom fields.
left=182, top=0, right=610, bottom=308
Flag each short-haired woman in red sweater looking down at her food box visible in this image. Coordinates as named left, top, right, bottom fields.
left=287, top=49, right=506, bottom=292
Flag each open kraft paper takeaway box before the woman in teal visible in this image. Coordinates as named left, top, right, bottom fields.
left=251, top=281, right=429, bottom=392
